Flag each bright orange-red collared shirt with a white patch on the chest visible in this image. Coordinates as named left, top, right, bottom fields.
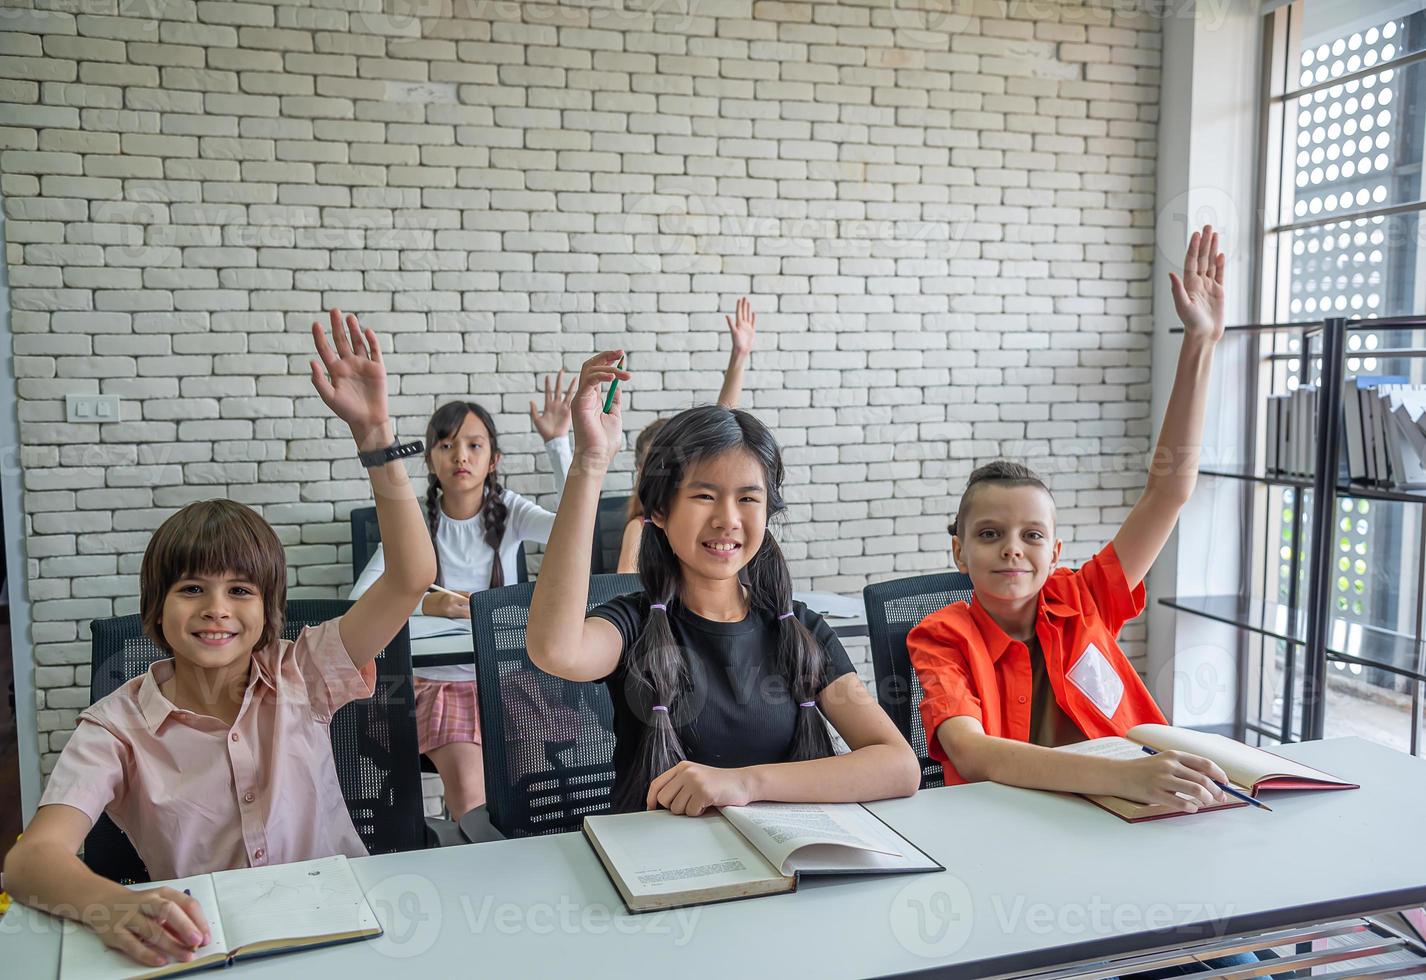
left=906, top=545, right=1165, bottom=785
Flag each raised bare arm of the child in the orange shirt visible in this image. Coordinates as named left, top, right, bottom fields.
left=1114, top=225, right=1224, bottom=591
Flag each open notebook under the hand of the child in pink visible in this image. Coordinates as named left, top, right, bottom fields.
left=60, top=854, right=381, bottom=980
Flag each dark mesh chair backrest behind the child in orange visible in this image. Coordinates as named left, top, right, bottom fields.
left=861, top=572, right=973, bottom=789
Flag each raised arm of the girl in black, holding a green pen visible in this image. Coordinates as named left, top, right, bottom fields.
left=525, top=351, right=633, bottom=680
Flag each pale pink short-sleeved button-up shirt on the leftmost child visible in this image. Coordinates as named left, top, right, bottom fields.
left=40, top=619, right=375, bottom=880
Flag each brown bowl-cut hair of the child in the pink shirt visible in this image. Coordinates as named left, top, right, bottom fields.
left=138, top=499, right=287, bottom=656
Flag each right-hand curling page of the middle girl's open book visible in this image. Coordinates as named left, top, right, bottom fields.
left=722, top=803, right=904, bottom=874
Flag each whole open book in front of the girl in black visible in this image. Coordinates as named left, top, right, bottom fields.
left=585, top=803, right=945, bottom=912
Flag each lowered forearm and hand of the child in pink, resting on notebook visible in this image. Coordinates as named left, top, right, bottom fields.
left=4, top=803, right=212, bottom=967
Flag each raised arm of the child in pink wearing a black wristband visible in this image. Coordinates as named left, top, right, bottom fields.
left=303, top=310, right=436, bottom=668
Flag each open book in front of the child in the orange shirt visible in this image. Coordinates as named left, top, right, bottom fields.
left=1058, top=725, right=1359, bottom=823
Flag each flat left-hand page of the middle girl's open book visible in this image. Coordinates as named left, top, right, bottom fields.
left=585, top=810, right=783, bottom=897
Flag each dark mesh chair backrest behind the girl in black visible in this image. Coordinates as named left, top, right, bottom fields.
left=471, top=575, right=640, bottom=837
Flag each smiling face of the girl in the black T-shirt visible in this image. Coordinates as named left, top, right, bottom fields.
left=652, top=449, right=767, bottom=581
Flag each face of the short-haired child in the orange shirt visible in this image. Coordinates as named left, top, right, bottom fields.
left=951, top=482, right=1062, bottom=608
